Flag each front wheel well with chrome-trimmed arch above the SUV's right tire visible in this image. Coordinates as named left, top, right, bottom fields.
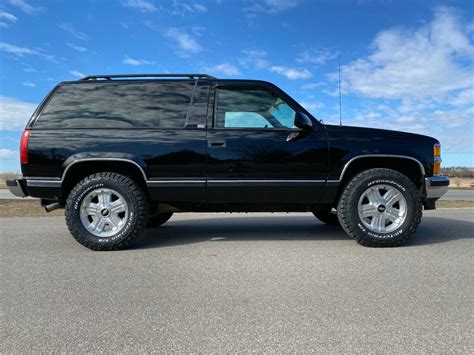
left=336, top=157, right=423, bottom=204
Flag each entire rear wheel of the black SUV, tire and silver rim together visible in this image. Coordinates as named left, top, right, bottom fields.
left=65, top=172, right=148, bottom=250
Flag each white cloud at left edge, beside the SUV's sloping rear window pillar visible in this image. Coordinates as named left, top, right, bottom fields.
left=0, top=96, right=37, bottom=131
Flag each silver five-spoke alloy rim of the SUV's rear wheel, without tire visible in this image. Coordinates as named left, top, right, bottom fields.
left=79, top=188, right=128, bottom=238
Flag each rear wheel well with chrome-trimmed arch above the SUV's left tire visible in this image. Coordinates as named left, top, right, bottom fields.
left=62, top=160, right=148, bottom=200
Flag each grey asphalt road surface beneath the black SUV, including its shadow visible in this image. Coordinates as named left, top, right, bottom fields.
left=0, top=209, right=474, bottom=353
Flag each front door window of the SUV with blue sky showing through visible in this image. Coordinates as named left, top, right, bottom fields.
left=216, top=88, right=295, bottom=128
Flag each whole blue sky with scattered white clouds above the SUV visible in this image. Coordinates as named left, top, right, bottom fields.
left=0, top=0, right=474, bottom=171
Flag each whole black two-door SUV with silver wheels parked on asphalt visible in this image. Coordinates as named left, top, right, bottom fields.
left=7, top=74, right=449, bottom=250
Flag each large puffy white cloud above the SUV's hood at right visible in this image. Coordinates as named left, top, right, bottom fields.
left=314, top=7, right=474, bottom=161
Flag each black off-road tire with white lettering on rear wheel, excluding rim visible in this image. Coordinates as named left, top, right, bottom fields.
left=65, top=172, right=149, bottom=250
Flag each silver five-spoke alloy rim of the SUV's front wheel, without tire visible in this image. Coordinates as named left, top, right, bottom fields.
left=357, top=184, right=407, bottom=233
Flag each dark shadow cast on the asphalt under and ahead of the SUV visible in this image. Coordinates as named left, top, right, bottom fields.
left=133, top=215, right=474, bottom=249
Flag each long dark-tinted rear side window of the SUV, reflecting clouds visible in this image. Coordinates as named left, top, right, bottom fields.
left=35, top=81, right=194, bottom=128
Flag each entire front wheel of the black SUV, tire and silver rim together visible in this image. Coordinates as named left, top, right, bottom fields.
left=337, top=169, right=422, bottom=247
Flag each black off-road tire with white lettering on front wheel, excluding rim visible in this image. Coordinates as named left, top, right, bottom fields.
left=337, top=169, right=423, bottom=247
